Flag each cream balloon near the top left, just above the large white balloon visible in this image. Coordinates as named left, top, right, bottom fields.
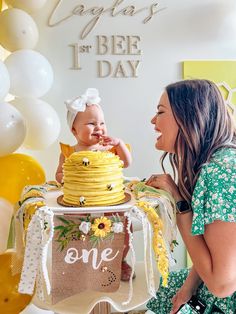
left=0, top=9, right=39, bottom=51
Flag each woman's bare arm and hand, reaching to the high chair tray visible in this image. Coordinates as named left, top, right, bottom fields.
left=147, top=174, right=236, bottom=298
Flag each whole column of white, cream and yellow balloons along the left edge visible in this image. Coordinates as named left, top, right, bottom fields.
left=0, top=0, right=53, bottom=314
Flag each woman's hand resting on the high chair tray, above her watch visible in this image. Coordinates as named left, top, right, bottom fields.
left=146, top=174, right=183, bottom=202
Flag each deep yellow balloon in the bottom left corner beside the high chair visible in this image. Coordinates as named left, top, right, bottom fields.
left=0, top=252, right=32, bottom=314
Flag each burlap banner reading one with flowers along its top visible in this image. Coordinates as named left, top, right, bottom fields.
left=52, top=215, right=125, bottom=304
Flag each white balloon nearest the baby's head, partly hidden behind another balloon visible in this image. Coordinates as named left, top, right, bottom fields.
left=11, top=98, right=60, bottom=150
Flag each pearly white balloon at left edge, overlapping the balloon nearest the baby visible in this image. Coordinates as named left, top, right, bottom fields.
left=0, top=102, right=26, bottom=156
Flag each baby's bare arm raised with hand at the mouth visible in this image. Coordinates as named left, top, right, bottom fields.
left=102, top=136, right=132, bottom=168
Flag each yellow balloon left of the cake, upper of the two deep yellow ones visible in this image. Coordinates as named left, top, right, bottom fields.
left=0, top=154, right=45, bottom=204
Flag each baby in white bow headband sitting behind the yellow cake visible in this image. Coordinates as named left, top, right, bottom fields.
left=56, top=88, right=132, bottom=281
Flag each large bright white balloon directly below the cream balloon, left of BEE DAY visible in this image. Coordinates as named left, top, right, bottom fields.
left=5, top=50, right=53, bottom=98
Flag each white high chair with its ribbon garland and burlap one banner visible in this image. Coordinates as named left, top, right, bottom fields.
left=15, top=183, right=175, bottom=314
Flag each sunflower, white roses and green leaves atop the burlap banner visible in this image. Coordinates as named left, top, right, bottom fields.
left=54, top=214, right=124, bottom=251
